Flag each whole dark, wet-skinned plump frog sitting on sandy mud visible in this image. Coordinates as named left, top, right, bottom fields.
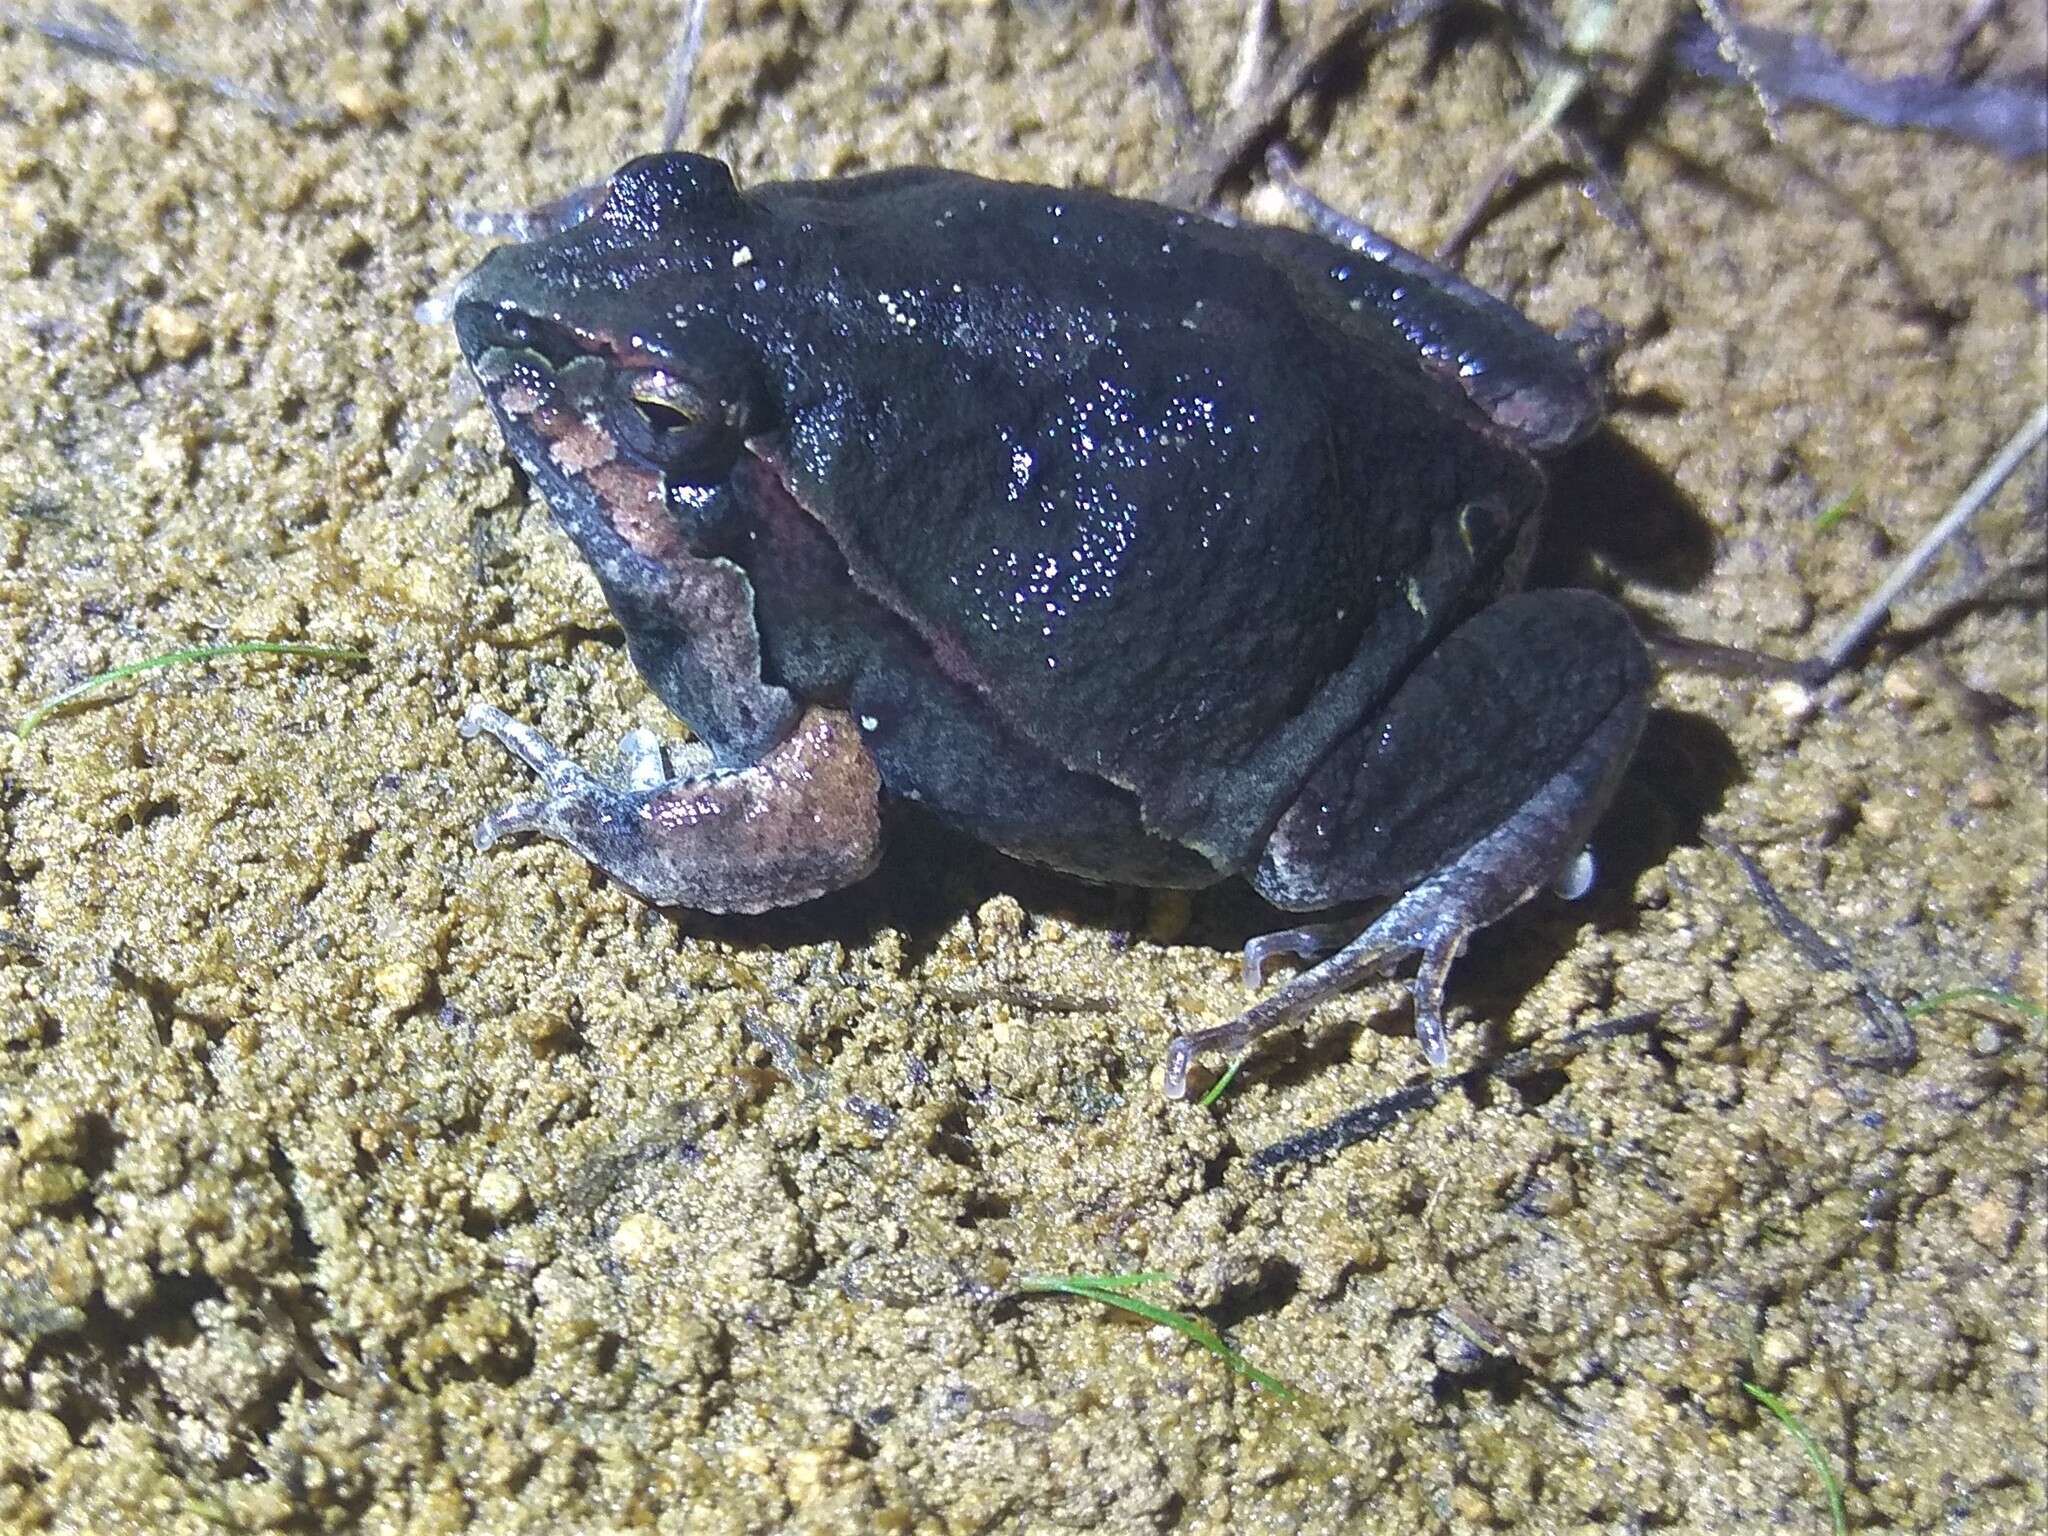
left=455, top=154, right=1651, bottom=1094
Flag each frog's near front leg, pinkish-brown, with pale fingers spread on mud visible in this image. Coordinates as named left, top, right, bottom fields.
left=461, top=705, right=881, bottom=911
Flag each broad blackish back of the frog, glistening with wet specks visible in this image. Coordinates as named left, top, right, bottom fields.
left=752, top=172, right=1540, bottom=868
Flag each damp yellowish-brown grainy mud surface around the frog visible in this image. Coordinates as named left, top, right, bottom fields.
left=0, top=0, right=2048, bottom=1534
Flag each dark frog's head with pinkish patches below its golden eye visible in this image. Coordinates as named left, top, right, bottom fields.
left=455, top=154, right=774, bottom=559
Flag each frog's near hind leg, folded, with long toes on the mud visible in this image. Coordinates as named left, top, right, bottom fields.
left=1165, top=592, right=1651, bottom=1098
